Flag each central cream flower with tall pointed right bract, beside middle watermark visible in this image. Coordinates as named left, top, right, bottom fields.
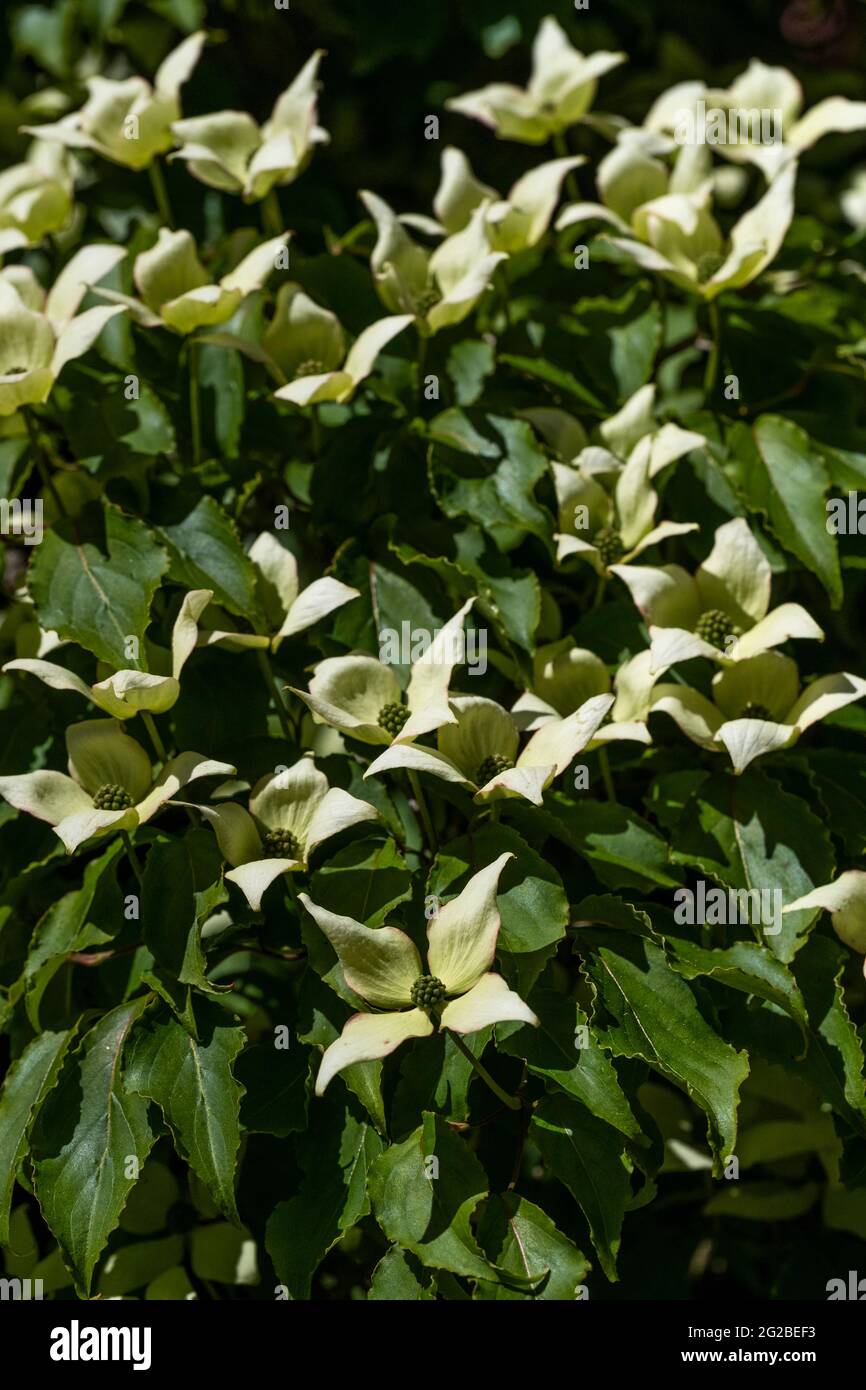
left=292, top=599, right=475, bottom=744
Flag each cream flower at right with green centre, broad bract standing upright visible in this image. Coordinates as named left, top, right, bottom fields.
left=610, top=517, right=824, bottom=674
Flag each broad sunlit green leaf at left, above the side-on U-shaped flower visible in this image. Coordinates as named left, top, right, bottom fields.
left=29, top=505, right=168, bottom=670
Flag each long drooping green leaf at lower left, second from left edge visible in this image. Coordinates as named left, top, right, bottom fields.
left=33, top=995, right=156, bottom=1298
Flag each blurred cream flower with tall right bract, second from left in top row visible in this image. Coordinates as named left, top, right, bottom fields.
left=171, top=49, right=329, bottom=203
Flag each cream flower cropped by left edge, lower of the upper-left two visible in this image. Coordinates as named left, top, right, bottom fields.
left=0, top=246, right=126, bottom=416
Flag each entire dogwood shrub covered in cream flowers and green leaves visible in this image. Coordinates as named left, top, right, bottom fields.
left=0, top=3, right=866, bottom=1301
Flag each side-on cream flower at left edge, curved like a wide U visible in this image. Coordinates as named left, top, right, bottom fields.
left=3, top=589, right=213, bottom=719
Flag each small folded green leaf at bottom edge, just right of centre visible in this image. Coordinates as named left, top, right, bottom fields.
left=475, top=1193, right=589, bottom=1302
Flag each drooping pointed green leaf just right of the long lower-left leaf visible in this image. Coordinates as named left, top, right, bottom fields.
left=126, top=1005, right=246, bottom=1222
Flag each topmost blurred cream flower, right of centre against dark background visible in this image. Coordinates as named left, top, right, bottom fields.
left=445, top=15, right=626, bottom=145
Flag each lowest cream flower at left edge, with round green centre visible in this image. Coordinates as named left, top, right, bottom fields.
left=0, top=719, right=236, bottom=853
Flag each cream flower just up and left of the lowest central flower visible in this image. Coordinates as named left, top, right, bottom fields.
left=187, top=753, right=378, bottom=912
